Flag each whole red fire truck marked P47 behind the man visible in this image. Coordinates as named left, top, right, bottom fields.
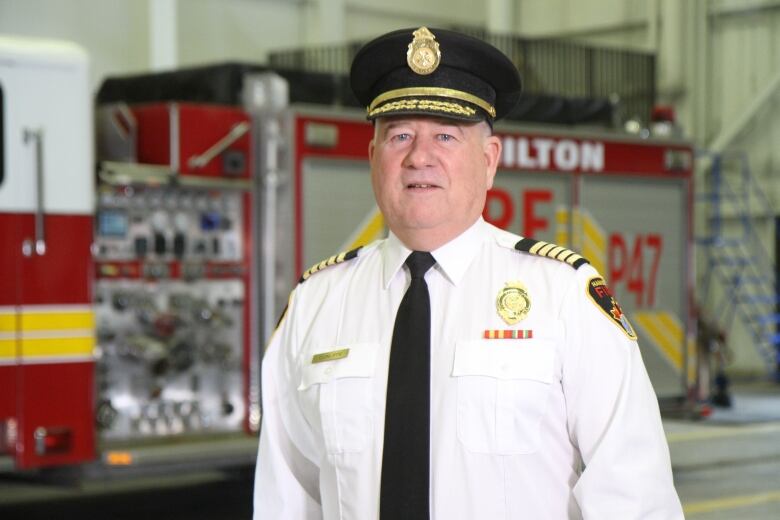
left=0, top=37, right=696, bottom=472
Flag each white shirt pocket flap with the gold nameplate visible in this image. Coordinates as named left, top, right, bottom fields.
left=298, top=343, right=379, bottom=390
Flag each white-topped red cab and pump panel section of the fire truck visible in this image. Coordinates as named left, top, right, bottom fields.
left=0, top=38, right=263, bottom=476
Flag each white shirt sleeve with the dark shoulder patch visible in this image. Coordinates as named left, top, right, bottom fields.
left=561, top=266, right=683, bottom=520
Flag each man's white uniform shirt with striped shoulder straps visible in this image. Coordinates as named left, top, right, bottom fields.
left=255, top=219, right=683, bottom=520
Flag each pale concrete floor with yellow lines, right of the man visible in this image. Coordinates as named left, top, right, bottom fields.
left=664, top=382, right=780, bottom=520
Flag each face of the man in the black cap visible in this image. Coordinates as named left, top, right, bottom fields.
left=368, top=116, right=501, bottom=251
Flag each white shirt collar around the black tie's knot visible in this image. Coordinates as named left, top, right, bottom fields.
left=382, top=216, right=487, bottom=289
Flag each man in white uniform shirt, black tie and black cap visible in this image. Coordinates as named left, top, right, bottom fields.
left=255, top=27, right=682, bottom=520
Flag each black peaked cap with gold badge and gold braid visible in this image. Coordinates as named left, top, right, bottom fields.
left=350, top=27, right=522, bottom=123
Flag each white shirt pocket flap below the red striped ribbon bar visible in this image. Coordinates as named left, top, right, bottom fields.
left=452, top=339, right=555, bottom=383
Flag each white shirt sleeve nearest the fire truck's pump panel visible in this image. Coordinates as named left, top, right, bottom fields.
left=254, top=288, right=322, bottom=520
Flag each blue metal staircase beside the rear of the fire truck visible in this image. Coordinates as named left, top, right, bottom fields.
left=697, top=153, right=780, bottom=381
